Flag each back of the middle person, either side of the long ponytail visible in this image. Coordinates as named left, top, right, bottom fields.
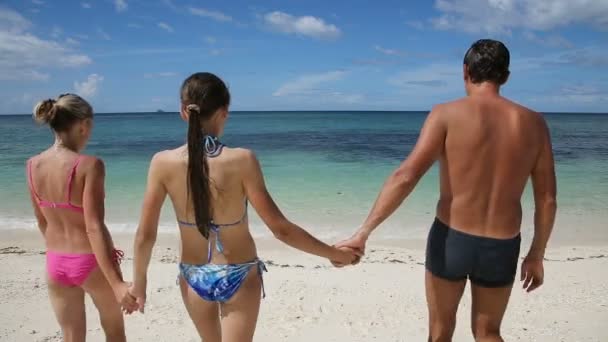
left=153, top=146, right=257, bottom=264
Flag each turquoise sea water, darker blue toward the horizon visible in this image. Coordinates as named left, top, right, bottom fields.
left=0, top=112, right=608, bottom=238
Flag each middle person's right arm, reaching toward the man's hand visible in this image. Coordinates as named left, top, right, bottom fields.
left=243, top=151, right=357, bottom=264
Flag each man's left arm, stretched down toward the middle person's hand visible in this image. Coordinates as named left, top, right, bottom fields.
left=358, top=106, right=447, bottom=239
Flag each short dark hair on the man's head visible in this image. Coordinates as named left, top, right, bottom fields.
left=464, top=39, right=510, bottom=85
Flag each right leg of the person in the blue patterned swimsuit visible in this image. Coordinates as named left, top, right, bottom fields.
left=222, top=266, right=262, bottom=342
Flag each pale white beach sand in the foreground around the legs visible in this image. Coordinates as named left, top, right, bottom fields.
left=0, top=231, right=608, bottom=342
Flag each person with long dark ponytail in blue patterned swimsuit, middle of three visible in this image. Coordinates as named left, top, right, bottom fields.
left=131, top=73, right=358, bottom=342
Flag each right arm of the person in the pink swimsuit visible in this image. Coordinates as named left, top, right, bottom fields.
left=82, top=158, right=133, bottom=304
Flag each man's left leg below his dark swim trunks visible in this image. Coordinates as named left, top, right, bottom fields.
left=425, top=271, right=466, bottom=342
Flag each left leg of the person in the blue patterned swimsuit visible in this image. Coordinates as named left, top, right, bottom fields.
left=179, top=276, right=222, bottom=342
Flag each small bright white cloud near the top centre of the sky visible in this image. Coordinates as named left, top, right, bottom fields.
left=264, top=11, right=342, bottom=39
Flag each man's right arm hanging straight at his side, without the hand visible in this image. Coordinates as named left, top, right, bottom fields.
left=528, top=120, right=557, bottom=260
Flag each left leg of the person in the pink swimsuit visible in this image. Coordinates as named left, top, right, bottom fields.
left=47, top=279, right=87, bottom=342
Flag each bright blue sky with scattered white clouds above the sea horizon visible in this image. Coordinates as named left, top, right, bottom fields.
left=0, top=0, right=608, bottom=114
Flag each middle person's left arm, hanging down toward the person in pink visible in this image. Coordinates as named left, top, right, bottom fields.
left=131, top=153, right=167, bottom=312
